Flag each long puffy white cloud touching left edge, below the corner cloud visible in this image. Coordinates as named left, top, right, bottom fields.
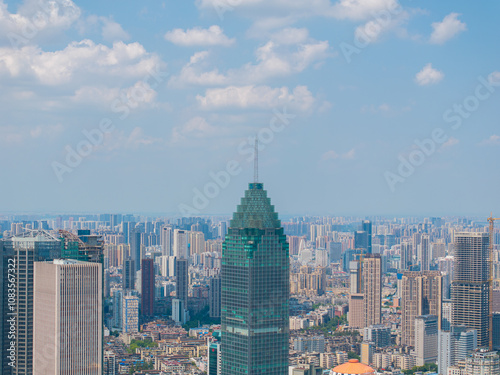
left=0, top=40, right=161, bottom=85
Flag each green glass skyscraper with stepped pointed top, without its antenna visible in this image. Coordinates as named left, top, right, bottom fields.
left=221, top=183, right=290, bottom=375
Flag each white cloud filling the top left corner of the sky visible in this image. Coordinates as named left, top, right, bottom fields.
left=0, top=0, right=81, bottom=47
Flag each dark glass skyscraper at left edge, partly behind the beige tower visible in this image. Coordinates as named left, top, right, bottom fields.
left=0, top=230, right=61, bottom=375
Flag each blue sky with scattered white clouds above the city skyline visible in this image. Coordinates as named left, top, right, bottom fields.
left=0, top=0, right=500, bottom=217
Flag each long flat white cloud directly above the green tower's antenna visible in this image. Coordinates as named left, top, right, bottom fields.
left=196, top=86, right=316, bottom=111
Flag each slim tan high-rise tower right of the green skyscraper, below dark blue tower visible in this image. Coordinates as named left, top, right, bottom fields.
left=363, top=254, right=382, bottom=327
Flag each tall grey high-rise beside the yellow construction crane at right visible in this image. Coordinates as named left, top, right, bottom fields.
left=451, top=232, right=490, bottom=346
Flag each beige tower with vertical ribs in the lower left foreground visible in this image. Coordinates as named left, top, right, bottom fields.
left=33, top=260, right=102, bottom=375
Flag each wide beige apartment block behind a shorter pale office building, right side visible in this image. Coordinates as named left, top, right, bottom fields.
left=401, top=271, right=442, bottom=346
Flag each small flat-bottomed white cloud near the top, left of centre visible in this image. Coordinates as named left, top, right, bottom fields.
left=165, top=25, right=235, bottom=47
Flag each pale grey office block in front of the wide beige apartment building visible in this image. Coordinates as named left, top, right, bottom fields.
left=415, top=315, right=439, bottom=366
